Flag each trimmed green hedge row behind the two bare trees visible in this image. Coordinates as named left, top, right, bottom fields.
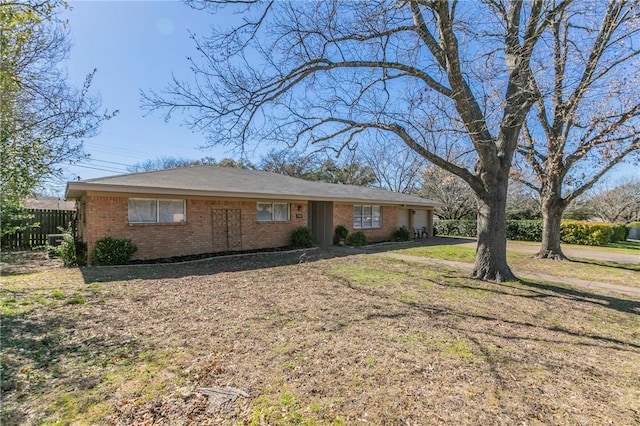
left=435, top=220, right=629, bottom=246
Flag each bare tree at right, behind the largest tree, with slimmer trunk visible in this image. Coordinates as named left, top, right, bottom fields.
left=519, top=0, right=640, bottom=259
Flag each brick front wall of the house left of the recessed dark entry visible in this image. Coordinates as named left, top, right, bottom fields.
left=81, top=192, right=307, bottom=261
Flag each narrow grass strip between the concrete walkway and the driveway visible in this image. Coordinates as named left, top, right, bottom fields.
left=397, top=246, right=640, bottom=287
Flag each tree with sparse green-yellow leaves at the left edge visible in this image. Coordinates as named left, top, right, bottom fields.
left=0, top=0, right=110, bottom=234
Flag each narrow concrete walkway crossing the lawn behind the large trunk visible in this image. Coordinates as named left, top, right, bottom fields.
left=375, top=251, right=640, bottom=298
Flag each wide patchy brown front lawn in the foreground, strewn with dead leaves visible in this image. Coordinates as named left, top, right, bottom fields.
left=0, top=248, right=640, bottom=425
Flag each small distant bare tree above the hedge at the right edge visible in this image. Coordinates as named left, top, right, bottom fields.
left=588, top=178, right=640, bottom=223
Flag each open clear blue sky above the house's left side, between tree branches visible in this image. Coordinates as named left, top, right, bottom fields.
left=58, top=1, right=232, bottom=190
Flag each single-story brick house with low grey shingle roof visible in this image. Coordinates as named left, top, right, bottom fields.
left=66, top=165, right=440, bottom=261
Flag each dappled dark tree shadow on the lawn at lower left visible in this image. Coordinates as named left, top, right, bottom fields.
left=0, top=307, right=144, bottom=424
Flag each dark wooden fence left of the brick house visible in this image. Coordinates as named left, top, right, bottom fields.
left=1, top=209, right=76, bottom=250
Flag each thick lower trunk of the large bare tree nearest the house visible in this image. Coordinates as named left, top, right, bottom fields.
left=471, top=182, right=517, bottom=282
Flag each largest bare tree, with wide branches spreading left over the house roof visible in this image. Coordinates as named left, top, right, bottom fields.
left=143, top=0, right=570, bottom=281
